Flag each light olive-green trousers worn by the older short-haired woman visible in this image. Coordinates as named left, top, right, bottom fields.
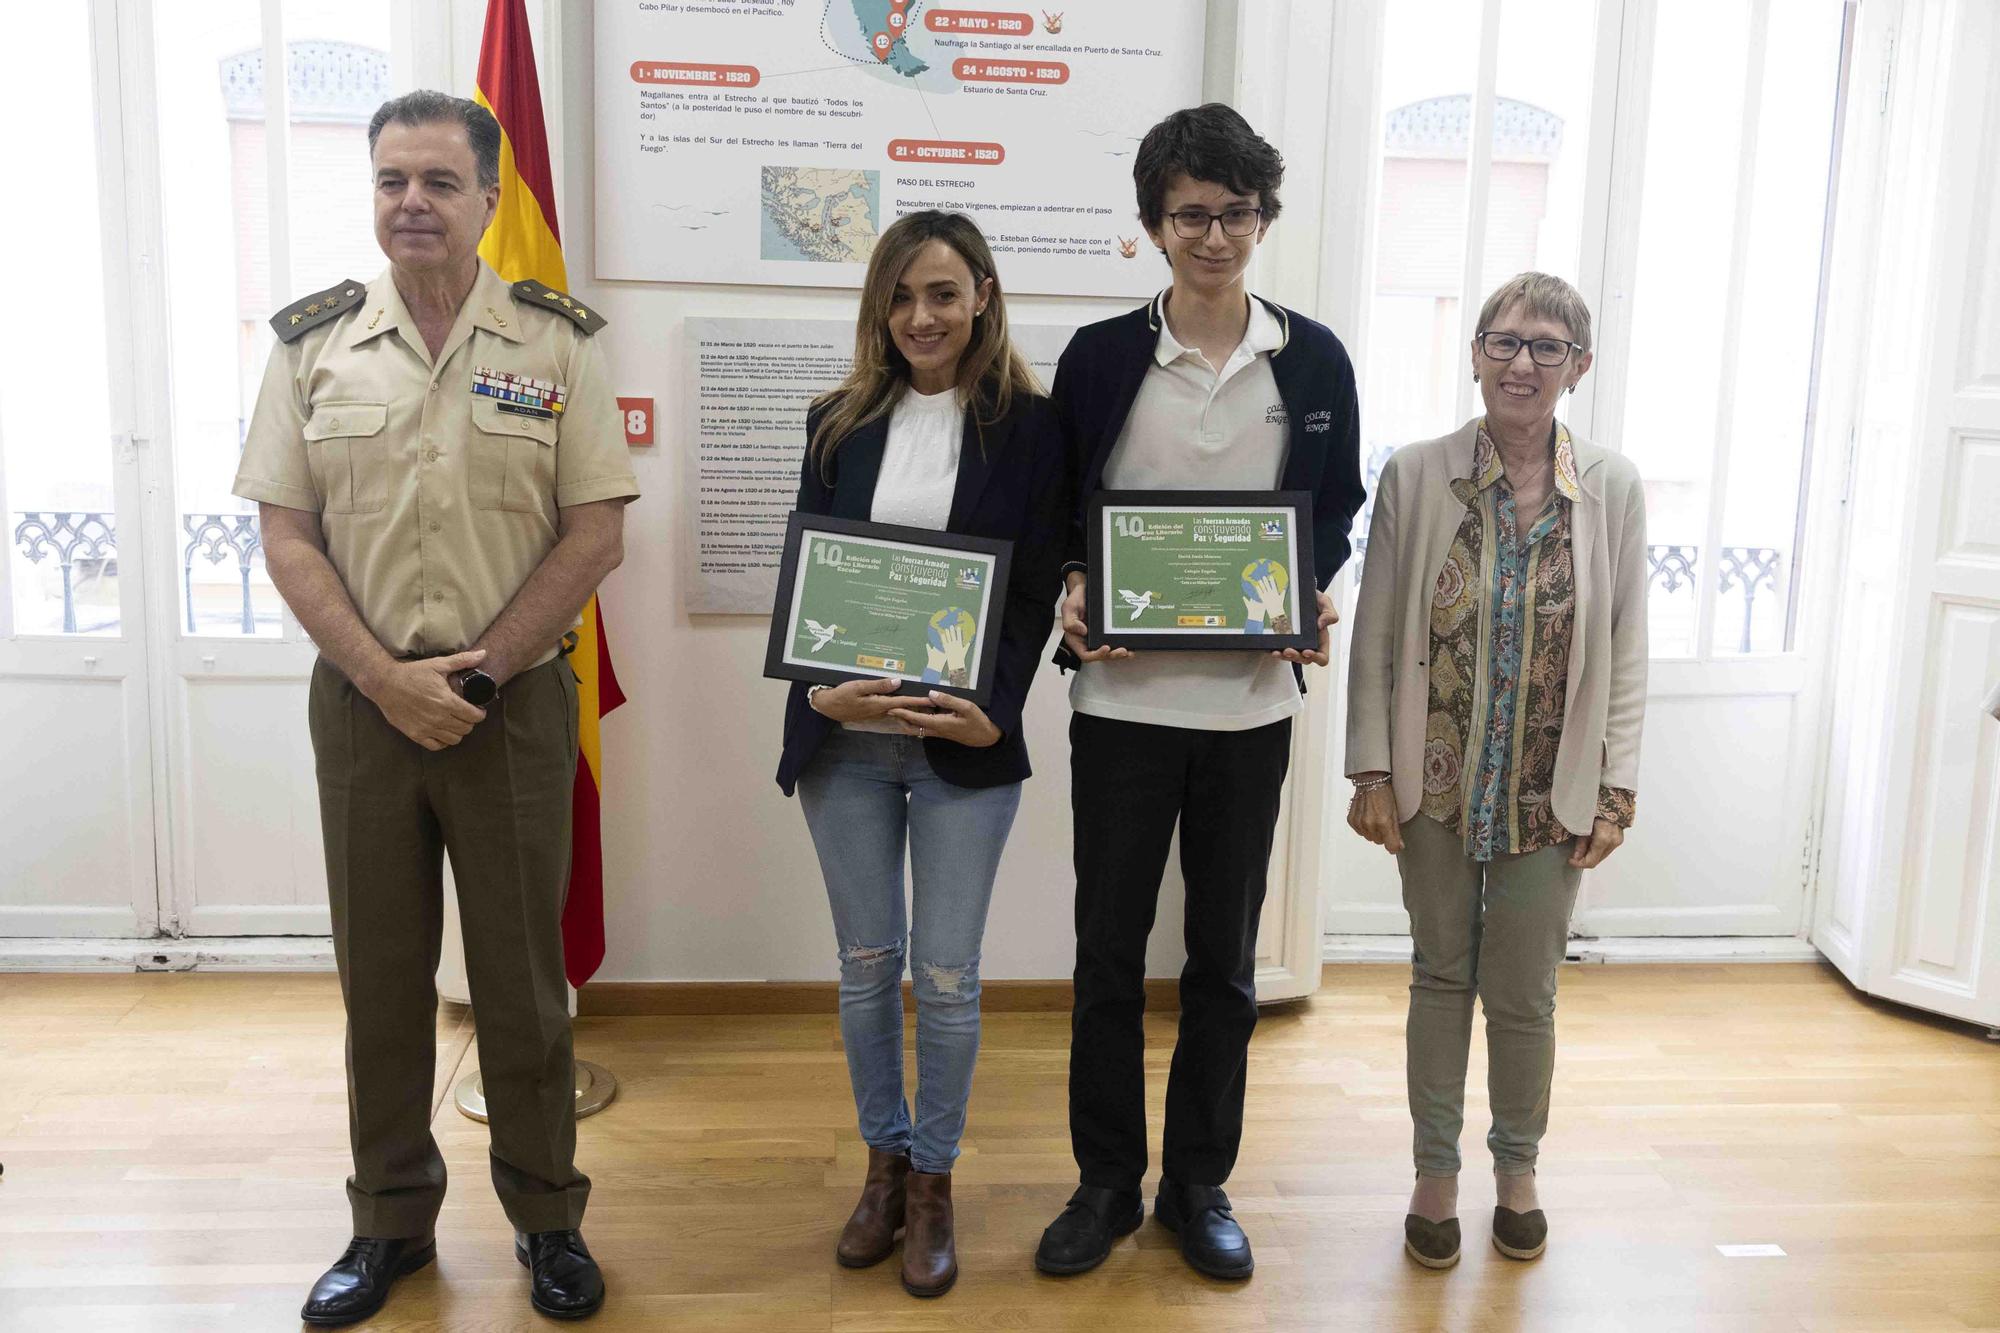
left=1396, top=815, right=1584, bottom=1175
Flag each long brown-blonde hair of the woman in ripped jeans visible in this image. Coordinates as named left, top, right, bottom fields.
left=808, top=210, right=1042, bottom=476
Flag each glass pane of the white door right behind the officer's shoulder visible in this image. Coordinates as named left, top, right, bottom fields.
left=156, top=0, right=390, bottom=636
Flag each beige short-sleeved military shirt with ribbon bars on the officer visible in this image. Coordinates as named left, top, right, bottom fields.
left=234, top=262, right=638, bottom=660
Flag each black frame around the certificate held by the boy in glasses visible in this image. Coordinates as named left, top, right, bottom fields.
left=1084, top=490, right=1320, bottom=652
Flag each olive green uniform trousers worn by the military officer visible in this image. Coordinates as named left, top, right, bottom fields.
left=308, top=656, right=590, bottom=1237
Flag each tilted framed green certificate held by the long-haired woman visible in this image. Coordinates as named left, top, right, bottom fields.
left=764, top=510, right=1014, bottom=707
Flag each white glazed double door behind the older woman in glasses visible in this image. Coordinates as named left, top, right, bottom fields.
left=1322, top=0, right=1846, bottom=937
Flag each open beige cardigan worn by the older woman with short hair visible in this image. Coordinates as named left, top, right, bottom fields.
left=1346, top=420, right=1646, bottom=833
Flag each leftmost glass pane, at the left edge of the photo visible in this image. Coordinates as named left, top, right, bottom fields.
left=0, top=4, right=120, bottom=634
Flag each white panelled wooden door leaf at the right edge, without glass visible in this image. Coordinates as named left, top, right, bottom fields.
left=1814, top=6, right=2000, bottom=1025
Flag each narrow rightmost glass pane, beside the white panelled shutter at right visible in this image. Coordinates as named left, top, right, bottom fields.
left=1714, top=0, right=1840, bottom=652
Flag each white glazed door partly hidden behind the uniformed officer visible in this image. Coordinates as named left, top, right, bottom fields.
left=128, top=0, right=392, bottom=935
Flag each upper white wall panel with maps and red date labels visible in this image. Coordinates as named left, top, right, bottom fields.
left=596, top=0, right=1206, bottom=296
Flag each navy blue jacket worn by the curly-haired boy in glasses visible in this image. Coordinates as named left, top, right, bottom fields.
left=1050, top=292, right=1368, bottom=675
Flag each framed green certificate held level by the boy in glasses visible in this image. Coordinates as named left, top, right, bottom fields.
left=1084, top=490, right=1320, bottom=652
